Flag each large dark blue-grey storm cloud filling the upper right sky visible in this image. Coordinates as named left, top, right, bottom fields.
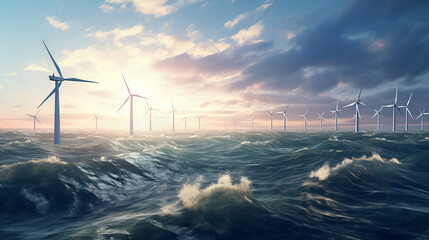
left=229, top=0, right=429, bottom=93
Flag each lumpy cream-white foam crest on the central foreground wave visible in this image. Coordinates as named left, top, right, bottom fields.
left=179, top=174, right=251, bottom=208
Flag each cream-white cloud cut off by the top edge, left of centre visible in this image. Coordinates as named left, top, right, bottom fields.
left=105, top=0, right=201, bottom=17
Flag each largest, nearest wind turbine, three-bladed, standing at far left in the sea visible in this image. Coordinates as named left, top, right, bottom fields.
left=37, top=41, right=98, bottom=144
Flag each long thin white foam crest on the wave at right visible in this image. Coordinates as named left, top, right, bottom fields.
left=309, top=153, right=401, bottom=181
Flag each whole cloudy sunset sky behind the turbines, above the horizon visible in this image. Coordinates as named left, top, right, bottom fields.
left=0, top=0, right=429, bottom=131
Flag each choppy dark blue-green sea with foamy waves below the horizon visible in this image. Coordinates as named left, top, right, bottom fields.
left=0, top=132, right=429, bottom=239
